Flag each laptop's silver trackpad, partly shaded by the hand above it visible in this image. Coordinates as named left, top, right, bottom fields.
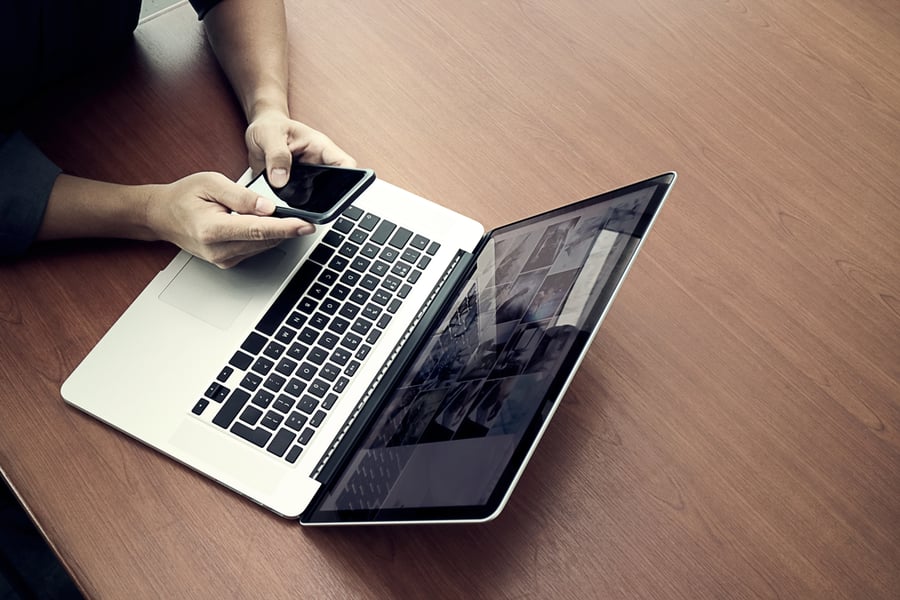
left=159, top=248, right=284, bottom=329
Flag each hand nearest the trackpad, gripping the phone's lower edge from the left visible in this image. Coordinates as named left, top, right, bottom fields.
left=146, top=173, right=315, bottom=269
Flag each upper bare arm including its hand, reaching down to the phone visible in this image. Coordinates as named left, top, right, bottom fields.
left=203, top=0, right=356, bottom=186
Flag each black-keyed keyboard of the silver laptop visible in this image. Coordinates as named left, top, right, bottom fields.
left=192, top=206, right=440, bottom=464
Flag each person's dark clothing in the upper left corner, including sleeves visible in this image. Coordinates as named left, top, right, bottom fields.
left=0, top=0, right=220, bottom=256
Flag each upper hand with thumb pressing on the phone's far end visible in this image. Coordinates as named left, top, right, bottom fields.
left=244, top=111, right=356, bottom=187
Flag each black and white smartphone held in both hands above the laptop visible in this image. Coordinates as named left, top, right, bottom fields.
left=247, top=160, right=375, bottom=223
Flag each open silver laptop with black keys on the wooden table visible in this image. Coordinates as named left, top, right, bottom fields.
left=62, top=173, right=675, bottom=525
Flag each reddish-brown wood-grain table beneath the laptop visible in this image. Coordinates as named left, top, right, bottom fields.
left=0, top=0, right=900, bottom=599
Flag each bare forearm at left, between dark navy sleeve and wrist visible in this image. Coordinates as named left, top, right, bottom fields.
left=37, top=175, right=157, bottom=240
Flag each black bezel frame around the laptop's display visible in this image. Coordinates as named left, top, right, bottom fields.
left=300, top=172, right=676, bottom=525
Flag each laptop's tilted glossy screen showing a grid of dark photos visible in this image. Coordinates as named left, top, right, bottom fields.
left=304, top=176, right=672, bottom=522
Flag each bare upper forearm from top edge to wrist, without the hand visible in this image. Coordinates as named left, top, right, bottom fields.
left=203, top=0, right=289, bottom=123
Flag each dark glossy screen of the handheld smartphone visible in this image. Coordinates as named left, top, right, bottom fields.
left=269, top=162, right=369, bottom=214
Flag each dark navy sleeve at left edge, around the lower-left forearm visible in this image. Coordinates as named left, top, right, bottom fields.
left=0, top=132, right=62, bottom=256
